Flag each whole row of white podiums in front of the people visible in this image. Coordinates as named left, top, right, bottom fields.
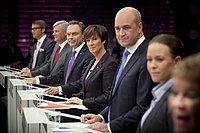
left=0, top=67, right=98, bottom=133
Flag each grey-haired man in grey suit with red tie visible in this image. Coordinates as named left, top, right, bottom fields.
left=23, top=20, right=71, bottom=85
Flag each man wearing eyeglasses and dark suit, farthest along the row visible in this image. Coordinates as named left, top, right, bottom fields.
left=21, top=20, right=55, bottom=74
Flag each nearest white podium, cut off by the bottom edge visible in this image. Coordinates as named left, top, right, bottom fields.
left=22, top=108, right=100, bottom=133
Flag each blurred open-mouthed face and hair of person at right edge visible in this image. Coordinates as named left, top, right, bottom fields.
left=168, top=54, right=200, bottom=133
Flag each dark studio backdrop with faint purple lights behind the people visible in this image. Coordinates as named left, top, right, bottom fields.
left=0, top=0, right=200, bottom=131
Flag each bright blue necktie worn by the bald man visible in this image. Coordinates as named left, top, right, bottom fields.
left=108, top=49, right=130, bottom=122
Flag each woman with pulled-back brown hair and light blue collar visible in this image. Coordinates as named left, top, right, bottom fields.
left=137, top=34, right=183, bottom=133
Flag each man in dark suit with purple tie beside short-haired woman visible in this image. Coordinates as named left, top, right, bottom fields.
left=31, top=21, right=94, bottom=97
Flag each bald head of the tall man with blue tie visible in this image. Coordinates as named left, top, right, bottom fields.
left=115, top=7, right=143, bottom=48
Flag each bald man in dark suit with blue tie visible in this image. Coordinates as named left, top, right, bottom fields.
left=81, top=7, right=155, bottom=133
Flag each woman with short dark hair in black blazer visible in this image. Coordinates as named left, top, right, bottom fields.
left=68, top=25, right=118, bottom=114
